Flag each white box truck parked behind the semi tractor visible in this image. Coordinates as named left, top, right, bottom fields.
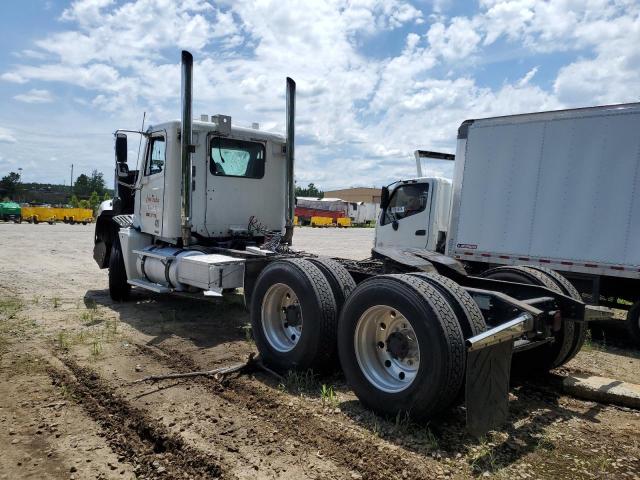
left=374, top=107, right=640, bottom=345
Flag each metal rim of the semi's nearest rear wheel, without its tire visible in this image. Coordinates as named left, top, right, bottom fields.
left=353, top=305, right=420, bottom=393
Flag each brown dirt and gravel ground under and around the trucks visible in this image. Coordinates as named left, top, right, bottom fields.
left=0, top=224, right=640, bottom=479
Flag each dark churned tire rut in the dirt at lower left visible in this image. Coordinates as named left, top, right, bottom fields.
left=48, top=357, right=228, bottom=479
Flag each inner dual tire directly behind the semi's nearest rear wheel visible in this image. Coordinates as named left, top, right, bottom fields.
left=411, top=273, right=487, bottom=340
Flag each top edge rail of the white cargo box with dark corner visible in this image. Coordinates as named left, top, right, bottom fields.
left=458, top=102, right=640, bottom=139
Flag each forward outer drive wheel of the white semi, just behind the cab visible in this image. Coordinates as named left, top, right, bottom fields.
left=251, top=258, right=338, bottom=371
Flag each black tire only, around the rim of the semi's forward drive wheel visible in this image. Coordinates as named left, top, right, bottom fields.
left=251, top=258, right=338, bottom=372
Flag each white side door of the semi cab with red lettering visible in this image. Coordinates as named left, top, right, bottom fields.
left=139, top=132, right=167, bottom=235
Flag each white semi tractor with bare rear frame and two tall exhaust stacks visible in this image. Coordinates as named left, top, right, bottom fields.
left=94, top=52, right=593, bottom=435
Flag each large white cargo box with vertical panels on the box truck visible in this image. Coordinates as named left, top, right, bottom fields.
left=448, top=104, right=640, bottom=278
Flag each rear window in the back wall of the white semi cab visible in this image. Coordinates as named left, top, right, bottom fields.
left=210, top=137, right=265, bottom=178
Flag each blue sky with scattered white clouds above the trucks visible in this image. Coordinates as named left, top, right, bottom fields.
left=0, top=0, right=640, bottom=189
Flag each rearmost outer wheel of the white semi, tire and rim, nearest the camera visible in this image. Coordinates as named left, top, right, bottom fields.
left=338, top=274, right=466, bottom=420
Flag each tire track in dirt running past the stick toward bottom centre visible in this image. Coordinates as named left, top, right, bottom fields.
left=137, top=345, right=437, bottom=480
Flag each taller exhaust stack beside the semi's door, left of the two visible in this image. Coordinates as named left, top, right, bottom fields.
left=180, top=50, right=193, bottom=247
